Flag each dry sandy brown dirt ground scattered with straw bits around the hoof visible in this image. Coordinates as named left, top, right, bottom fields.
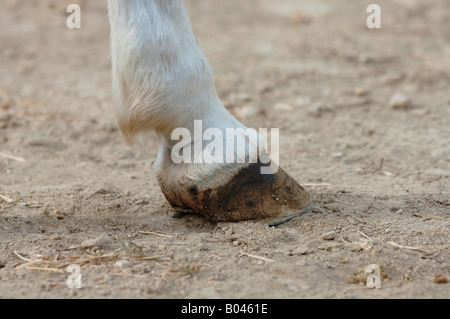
left=0, top=0, right=450, bottom=298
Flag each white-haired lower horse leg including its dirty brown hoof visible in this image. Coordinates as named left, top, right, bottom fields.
left=108, top=0, right=309, bottom=225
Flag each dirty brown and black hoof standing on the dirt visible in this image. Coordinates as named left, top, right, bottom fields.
left=158, top=162, right=312, bottom=226
